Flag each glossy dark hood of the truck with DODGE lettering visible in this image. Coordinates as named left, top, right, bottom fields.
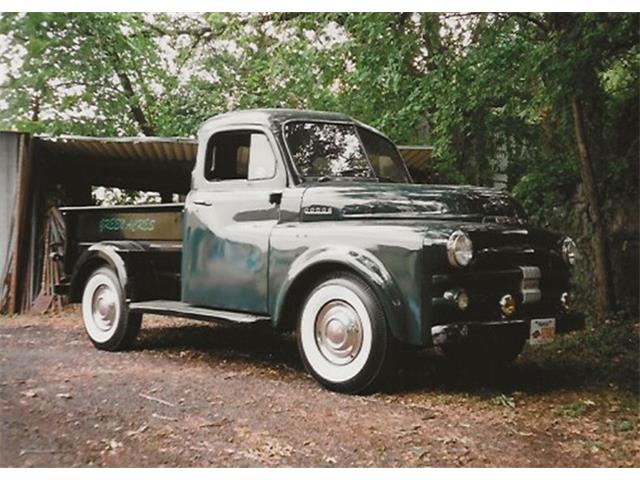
left=301, top=182, right=524, bottom=223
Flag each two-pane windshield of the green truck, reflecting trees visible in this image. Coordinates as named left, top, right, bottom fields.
left=284, top=121, right=409, bottom=183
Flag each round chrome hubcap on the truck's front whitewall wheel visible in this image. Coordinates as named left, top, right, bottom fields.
left=315, top=300, right=362, bottom=365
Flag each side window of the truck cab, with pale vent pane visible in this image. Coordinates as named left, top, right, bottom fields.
left=204, top=131, right=276, bottom=181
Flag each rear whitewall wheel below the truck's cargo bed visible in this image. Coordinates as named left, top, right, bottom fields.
left=82, top=267, right=142, bottom=351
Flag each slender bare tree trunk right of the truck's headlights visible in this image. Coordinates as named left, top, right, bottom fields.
left=571, top=97, right=614, bottom=315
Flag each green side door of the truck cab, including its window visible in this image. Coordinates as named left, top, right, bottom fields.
left=182, top=128, right=286, bottom=313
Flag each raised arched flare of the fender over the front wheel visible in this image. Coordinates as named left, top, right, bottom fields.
left=272, top=245, right=411, bottom=343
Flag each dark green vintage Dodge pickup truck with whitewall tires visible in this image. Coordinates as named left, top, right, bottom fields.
left=58, top=110, right=584, bottom=393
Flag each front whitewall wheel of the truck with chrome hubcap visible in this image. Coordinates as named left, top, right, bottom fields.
left=297, top=272, right=393, bottom=393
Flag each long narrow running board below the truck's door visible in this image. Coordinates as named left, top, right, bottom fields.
left=129, top=300, right=270, bottom=324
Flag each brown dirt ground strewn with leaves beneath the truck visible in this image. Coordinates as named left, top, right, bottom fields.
left=0, top=310, right=640, bottom=467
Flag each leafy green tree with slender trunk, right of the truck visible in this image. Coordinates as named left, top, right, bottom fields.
left=410, top=14, right=640, bottom=315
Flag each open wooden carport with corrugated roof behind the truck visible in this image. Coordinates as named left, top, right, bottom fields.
left=0, top=132, right=431, bottom=313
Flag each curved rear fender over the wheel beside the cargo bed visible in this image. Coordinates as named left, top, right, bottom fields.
left=69, top=243, right=130, bottom=302
